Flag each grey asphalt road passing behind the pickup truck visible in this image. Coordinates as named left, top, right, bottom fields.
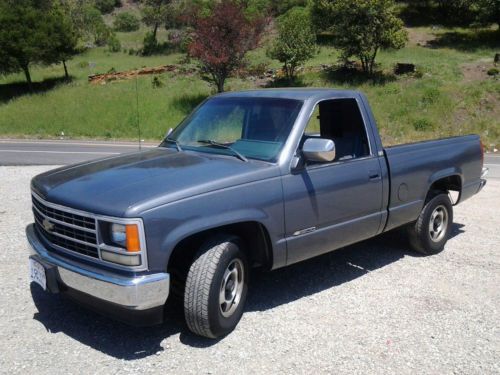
left=0, top=139, right=500, bottom=179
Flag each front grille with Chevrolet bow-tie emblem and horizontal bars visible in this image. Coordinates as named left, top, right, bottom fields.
left=32, top=195, right=99, bottom=258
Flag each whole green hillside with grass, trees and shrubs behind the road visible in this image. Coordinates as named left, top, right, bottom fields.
left=0, top=0, right=500, bottom=150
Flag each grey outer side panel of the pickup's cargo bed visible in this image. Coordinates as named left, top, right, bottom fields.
left=384, top=135, right=483, bottom=230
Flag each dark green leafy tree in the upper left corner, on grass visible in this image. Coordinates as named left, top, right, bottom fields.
left=0, top=0, right=76, bottom=86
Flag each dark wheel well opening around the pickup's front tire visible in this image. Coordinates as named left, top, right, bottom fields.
left=167, top=221, right=273, bottom=296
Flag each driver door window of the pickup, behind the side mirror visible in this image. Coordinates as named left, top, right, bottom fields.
left=304, top=99, right=370, bottom=161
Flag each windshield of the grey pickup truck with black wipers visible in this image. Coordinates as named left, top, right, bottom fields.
left=160, top=96, right=302, bottom=161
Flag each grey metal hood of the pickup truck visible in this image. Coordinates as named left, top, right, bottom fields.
left=31, top=147, right=279, bottom=217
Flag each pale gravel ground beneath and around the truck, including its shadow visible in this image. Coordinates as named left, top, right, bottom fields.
left=0, top=167, right=500, bottom=374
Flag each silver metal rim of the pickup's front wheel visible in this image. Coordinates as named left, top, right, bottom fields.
left=219, top=259, right=244, bottom=318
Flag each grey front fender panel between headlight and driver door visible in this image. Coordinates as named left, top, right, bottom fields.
left=144, top=178, right=286, bottom=271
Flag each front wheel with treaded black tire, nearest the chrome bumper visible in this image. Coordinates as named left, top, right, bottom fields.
left=184, top=236, right=249, bottom=338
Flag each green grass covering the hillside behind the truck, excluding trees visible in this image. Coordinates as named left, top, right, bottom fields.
left=0, top=23, right=500, bottom=148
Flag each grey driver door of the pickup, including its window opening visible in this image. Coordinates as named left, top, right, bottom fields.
left=283, top=99, right=383, bottom=264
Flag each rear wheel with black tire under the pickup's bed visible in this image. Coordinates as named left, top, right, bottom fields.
left=408, top=192, right=453, bottom=255
